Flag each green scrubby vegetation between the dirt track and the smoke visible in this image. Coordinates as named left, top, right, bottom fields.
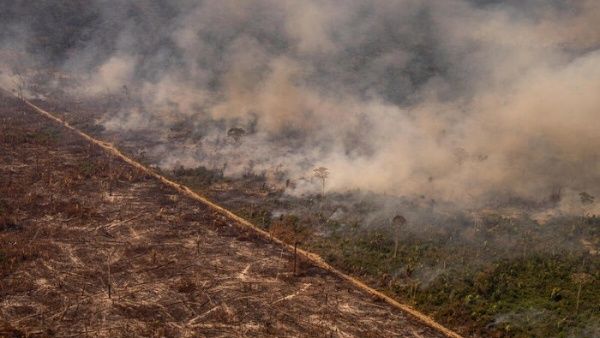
left=165, top=168, right=600, bottom=337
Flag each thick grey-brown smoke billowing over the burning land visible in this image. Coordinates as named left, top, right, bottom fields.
left=0, top=0, right=600, bottom=212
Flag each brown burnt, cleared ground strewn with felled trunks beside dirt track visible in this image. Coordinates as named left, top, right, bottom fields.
left=0, top=93, right=450, bottom=337
